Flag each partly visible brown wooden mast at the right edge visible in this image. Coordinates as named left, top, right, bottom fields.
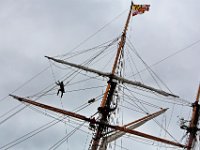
left=187, top=84, right=200, bottom=150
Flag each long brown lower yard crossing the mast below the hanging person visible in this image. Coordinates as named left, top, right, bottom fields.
left=10, top=95, right=186, bottom=148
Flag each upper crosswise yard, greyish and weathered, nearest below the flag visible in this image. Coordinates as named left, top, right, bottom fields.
left=45, top=56, right=178, bottom=98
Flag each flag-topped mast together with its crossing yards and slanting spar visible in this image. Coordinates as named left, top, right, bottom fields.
left=10, top=2, right=186, bottom=150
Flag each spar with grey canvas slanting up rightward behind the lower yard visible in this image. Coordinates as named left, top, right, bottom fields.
left=100, top=109, right=167, bottom=150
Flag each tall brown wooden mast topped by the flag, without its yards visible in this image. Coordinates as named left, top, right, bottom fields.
left=91, top=2, right=133, bottom=150
